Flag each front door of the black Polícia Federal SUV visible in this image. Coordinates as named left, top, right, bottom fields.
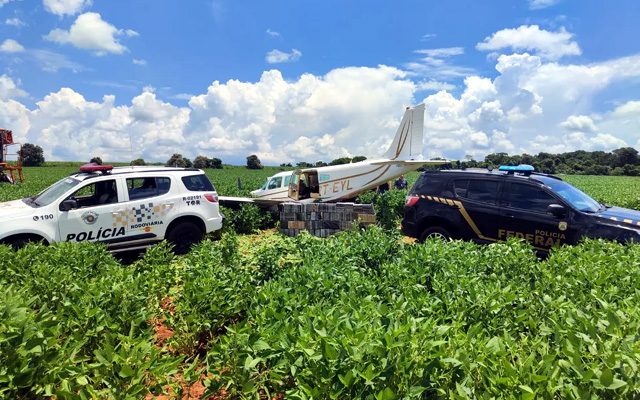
left=498, top=182, right=568, bottom=250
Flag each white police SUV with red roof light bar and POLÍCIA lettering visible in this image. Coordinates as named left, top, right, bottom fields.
left=0, top=164, right=222, bottom=254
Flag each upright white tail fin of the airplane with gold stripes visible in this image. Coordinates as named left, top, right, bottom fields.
left=384, top=104, right=424, bottom=160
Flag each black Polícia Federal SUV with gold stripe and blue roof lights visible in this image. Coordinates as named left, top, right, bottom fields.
left=402, top=166, right=640, bottom=251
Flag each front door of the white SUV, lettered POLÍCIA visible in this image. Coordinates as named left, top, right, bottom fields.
left=58, top=179, right=126, bottom=242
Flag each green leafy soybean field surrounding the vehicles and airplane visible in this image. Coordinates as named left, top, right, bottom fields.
left=0, top=166, right=640, bottom=400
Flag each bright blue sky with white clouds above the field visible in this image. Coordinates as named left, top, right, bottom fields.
left=0, top=0, right=640, bottom=165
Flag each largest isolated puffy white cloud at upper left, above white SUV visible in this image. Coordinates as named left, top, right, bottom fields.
left=44, top=12, right=138, bottom=55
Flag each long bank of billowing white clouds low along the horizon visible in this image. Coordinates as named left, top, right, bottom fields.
left=0, top=53, right=640, bottom=164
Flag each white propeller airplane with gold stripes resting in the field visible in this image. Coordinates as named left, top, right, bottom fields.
left=230, top=104, right=451, bottom=204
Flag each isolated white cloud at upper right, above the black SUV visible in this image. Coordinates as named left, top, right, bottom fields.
left=476, top=25, right=582, bottom=60
